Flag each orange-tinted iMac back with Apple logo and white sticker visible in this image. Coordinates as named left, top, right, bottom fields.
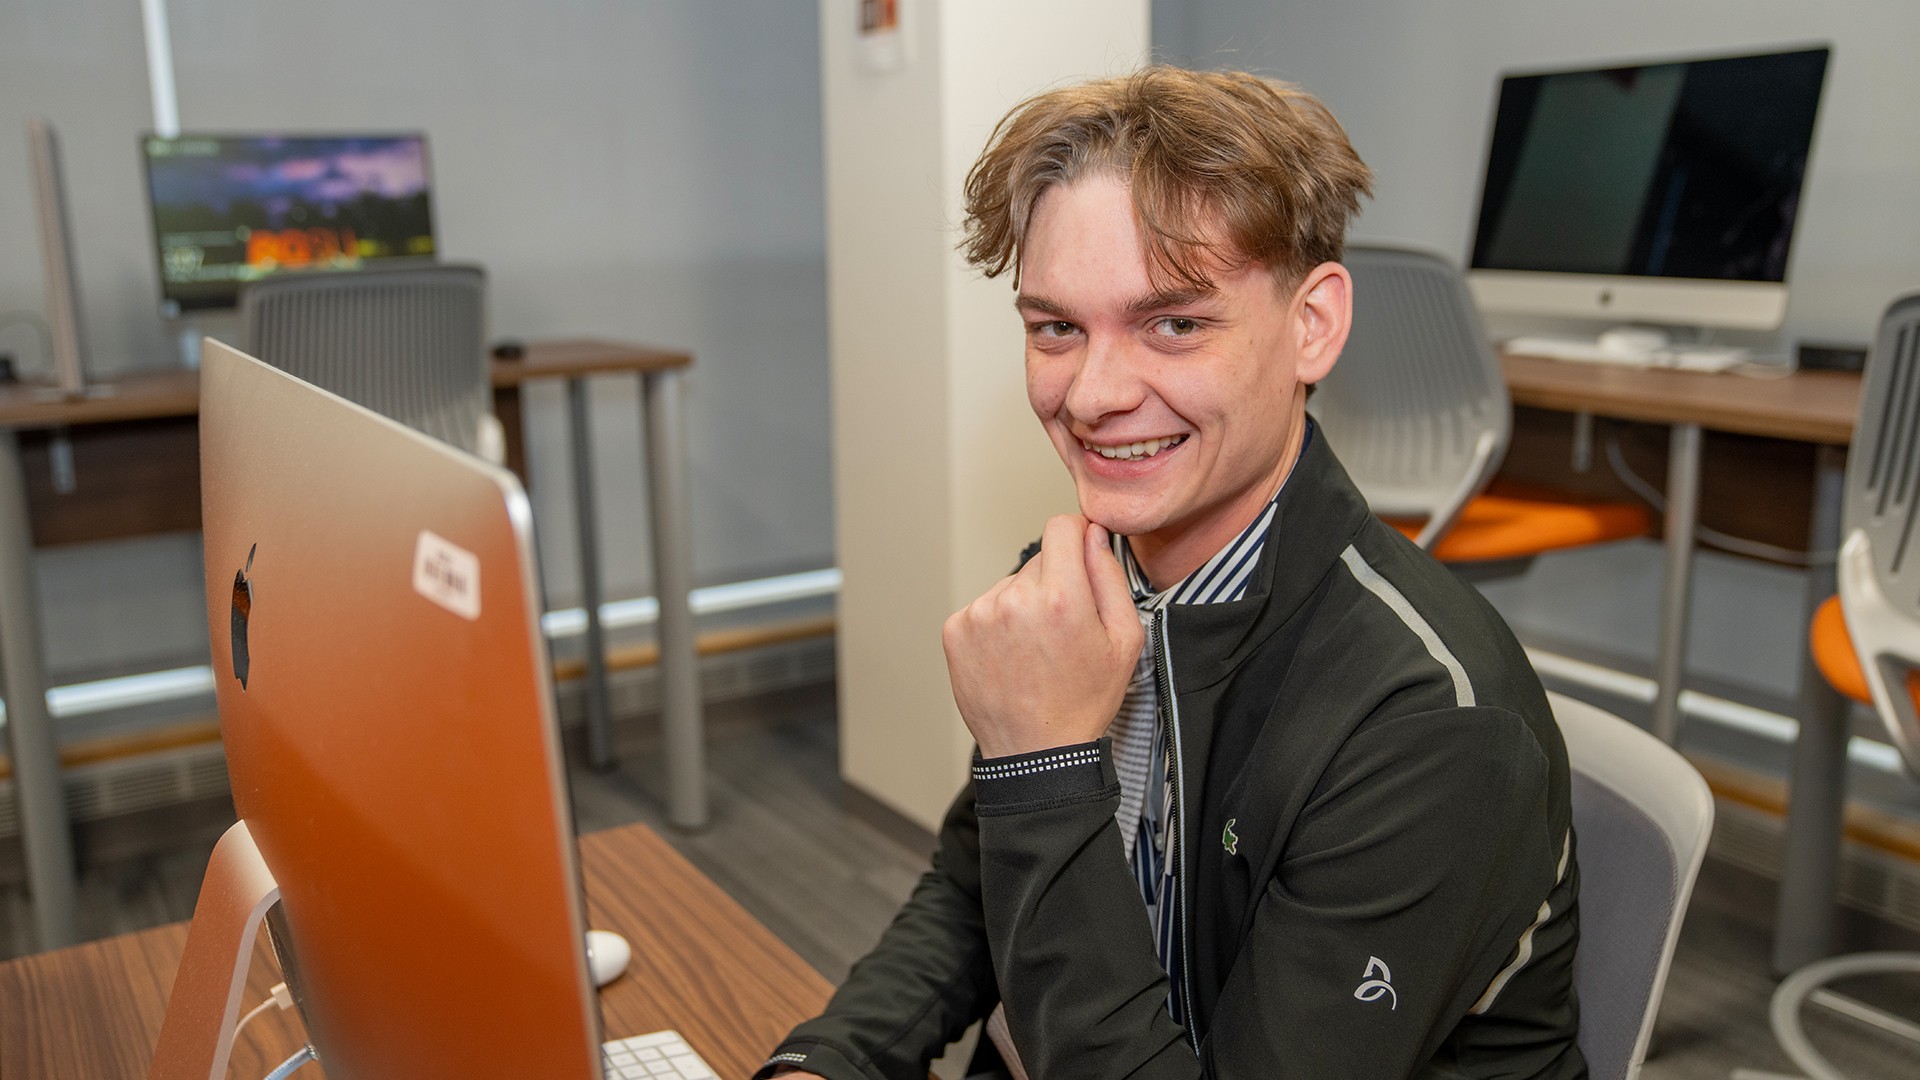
left=200, top=342, right=601, bottom=1080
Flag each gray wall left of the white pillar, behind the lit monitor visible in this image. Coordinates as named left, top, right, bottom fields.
left=0, top=0, right=833, bottom=676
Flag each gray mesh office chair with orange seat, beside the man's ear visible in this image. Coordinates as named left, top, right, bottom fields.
left=1308, top=246, right=1653, bottom=573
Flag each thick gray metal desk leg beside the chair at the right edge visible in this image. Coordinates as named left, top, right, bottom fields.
left=1774, top=446, right=1849, bottom=974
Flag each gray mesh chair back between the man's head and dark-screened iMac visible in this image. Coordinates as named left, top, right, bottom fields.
left=1308, top=246, right=1513, bottom=548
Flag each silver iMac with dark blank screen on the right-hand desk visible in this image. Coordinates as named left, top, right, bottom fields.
left=1469, top=48, right=1828, bottom=331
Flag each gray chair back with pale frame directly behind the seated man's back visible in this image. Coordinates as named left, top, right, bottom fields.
left=1548, top=694, right=1713, bottom=1080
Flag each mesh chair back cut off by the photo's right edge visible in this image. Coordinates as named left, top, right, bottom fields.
left=1837, top=294, right=1920, bottom=774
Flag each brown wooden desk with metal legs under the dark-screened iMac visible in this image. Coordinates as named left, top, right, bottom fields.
left=1501, top=356, right=1860, bottom=972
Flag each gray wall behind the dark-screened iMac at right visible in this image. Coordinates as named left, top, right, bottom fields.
left=1156, top=0, right=1920, bottom=348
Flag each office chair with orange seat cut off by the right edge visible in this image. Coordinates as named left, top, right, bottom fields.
left=1770, top=294, right=1920, bottom=1080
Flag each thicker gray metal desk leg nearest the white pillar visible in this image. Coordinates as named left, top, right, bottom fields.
left=641, top=371, right=707, bottom=828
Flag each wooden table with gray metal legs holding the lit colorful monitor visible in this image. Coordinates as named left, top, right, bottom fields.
left=0, top=340, right=707, bottom=947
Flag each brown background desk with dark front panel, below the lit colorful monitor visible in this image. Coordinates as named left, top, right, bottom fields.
left=0, top=340, right=707, bottom=947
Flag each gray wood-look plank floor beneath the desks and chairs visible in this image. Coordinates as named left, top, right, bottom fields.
left=0, top=688, right=1920, bottom=1080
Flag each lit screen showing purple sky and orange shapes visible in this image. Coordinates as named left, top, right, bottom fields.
left=142, top=135, right=436, bottom=315
